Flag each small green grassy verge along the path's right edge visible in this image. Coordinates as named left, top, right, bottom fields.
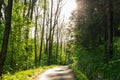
left=70, top=66, right=88, bottom=80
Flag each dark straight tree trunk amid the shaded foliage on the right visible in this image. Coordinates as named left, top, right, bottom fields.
left=107, top=0, right=113, bottom=59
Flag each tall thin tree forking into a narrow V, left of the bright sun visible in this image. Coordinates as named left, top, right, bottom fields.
left=48, top=0, right=62, bottom=65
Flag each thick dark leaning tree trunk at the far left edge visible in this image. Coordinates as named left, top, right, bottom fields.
left=0, top=0, right=13, bottom=76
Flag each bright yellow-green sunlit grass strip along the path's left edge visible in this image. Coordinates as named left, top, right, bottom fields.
left=2, top=66, right=55, bottom=80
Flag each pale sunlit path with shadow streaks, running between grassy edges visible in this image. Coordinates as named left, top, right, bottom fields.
left=34, top=66, right=76, bottom=80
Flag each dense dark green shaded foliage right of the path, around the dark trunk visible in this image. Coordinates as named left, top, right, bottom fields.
left=67, top=0, right=120, bottom=80
